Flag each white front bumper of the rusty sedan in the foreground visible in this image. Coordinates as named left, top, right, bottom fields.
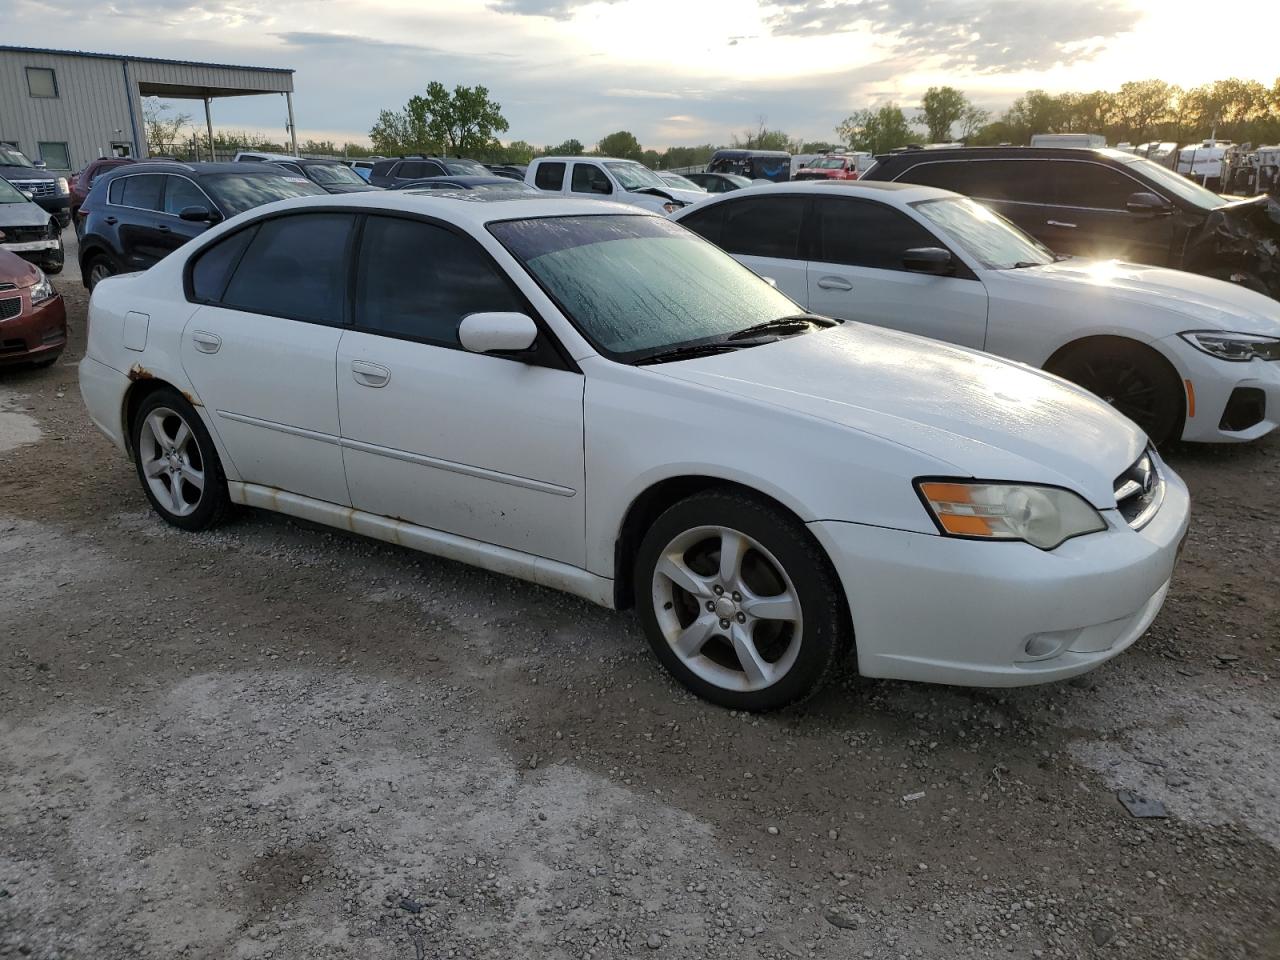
left=809, top=465, right=1190, bottom=687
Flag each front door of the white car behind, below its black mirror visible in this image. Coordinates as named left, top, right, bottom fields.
left=809, top=196, right=987, bottom=349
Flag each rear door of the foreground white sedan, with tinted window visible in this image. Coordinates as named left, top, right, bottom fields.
left=182, top=214, right=355, bottom=506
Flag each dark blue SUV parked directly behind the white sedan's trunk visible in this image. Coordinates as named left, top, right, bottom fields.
left=79, top=160, right=324, bottom=289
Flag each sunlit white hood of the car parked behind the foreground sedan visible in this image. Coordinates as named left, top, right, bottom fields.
left=998, top=259, right=1280, bottom=337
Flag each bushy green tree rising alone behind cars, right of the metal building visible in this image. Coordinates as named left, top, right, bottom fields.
left=369, top=81, right=508, bottom=154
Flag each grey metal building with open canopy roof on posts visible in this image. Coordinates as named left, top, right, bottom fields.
left=0, top=45, right=297, bottom=170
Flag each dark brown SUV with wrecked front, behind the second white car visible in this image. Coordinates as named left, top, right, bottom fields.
left=863, top=147, right=1280, bottom=298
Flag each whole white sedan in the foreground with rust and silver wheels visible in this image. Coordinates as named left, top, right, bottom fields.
left=79, top=192, right=1188, bottom=709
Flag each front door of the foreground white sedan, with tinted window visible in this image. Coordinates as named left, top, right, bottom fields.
left=337, top=216, right=585, bottom=566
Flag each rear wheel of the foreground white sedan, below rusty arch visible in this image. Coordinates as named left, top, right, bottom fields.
left=129, top=388, right=230, bottom=530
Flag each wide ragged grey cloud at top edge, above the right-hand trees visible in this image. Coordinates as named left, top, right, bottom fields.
left=762, top=0, right=1142, bottom=73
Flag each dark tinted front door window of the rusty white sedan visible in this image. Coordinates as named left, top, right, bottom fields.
left=356, top=216, right=527, bottom=346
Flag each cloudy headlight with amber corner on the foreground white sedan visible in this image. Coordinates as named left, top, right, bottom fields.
left=916, top=480, right=1107, bottom=550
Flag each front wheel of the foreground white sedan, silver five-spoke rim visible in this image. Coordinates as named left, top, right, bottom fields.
left=634, top=490, right=852, bottom=710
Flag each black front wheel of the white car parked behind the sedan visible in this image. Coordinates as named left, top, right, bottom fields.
left=1050, top=340, right=1187, bottom=447
